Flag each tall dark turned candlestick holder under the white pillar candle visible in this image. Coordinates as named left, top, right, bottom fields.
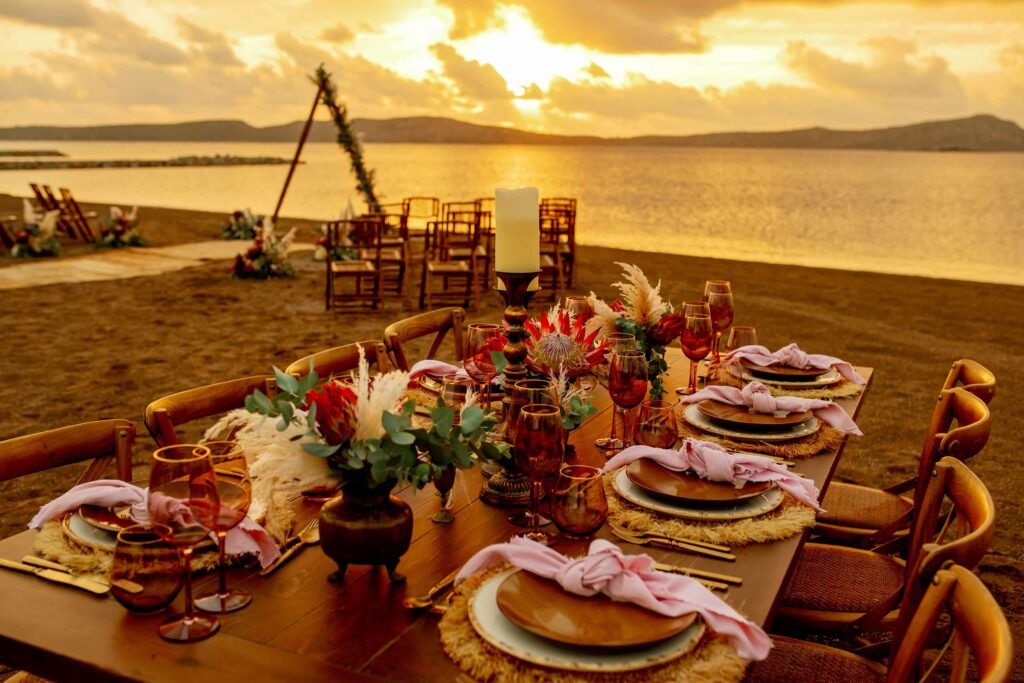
left=480, top=272, right=541, bottom=507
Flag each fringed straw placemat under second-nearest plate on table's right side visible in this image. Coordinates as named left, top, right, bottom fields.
left=604, top=472, right=815, bottom=546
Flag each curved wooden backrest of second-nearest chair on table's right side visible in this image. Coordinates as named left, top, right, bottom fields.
left=894, top=454, right=995, bottom=643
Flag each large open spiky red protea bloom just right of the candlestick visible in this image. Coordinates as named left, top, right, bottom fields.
left=524, top=304, right=605, bottom=379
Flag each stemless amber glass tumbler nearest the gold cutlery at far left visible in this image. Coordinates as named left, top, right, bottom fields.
left=109, top=524, right=183, bottom=614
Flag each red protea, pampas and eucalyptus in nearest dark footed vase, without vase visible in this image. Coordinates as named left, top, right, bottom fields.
left=246, top=347, right=508, bottom=488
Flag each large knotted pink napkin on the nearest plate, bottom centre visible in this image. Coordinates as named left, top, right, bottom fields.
left=455, top=537, right=771, bottom=660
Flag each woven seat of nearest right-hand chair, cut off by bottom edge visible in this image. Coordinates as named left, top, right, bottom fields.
left=744, top=636, right=886, bottom=683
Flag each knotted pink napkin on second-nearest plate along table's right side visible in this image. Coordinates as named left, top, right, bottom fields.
left=604, top=438, right=824, bottom=512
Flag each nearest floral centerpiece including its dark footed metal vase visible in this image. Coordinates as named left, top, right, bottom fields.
left=246, top=348, right=508, bottom=581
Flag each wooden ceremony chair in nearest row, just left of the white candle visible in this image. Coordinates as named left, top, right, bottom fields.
left=420, top=220, right=480, bottom=310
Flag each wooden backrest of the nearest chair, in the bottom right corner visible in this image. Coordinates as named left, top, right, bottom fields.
left=886, top=564, right=1014, bottom=683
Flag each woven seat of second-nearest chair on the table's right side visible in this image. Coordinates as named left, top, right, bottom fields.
left=781, top=543, right=903, bottom=612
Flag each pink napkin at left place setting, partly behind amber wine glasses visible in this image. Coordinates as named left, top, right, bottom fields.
left=29, top=479, right=281, bottom=567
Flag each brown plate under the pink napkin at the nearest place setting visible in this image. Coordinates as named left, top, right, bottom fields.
left=497, top=570, right=696, bottom=647
